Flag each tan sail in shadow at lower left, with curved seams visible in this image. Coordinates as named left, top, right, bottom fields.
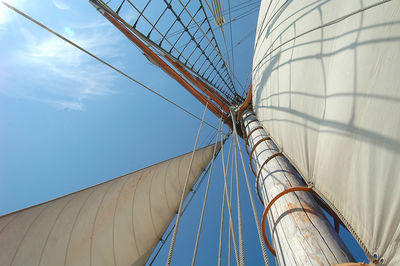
left=0, top=145, right=219, bottom=265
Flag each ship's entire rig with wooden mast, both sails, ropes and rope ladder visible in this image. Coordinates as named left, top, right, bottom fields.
left=0, top=0, right=400, bottom=265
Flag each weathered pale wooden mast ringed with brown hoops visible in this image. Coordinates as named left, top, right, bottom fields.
left=241, top=110, right=354, bottom=265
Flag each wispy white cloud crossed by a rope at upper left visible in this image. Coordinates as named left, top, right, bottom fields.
left=8, top=20, right=122, bottom=111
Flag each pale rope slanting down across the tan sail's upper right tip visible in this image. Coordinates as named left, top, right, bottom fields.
left=166, top=102, right=208, bottom=266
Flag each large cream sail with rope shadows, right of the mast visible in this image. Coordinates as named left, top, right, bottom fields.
left=253, top=0, right=400, bottom=265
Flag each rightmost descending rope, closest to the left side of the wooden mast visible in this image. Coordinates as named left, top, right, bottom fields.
left=231, top=111, right=269, bottom=265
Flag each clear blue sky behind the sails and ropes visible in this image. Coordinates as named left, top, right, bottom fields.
left=0, top=0, right=363, bottom=265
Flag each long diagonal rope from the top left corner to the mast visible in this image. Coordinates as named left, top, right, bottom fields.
left=1, top=1, right=217, bottom=130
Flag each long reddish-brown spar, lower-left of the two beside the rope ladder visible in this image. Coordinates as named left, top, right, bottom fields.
left=98, top=7, right=229, bottom=121
